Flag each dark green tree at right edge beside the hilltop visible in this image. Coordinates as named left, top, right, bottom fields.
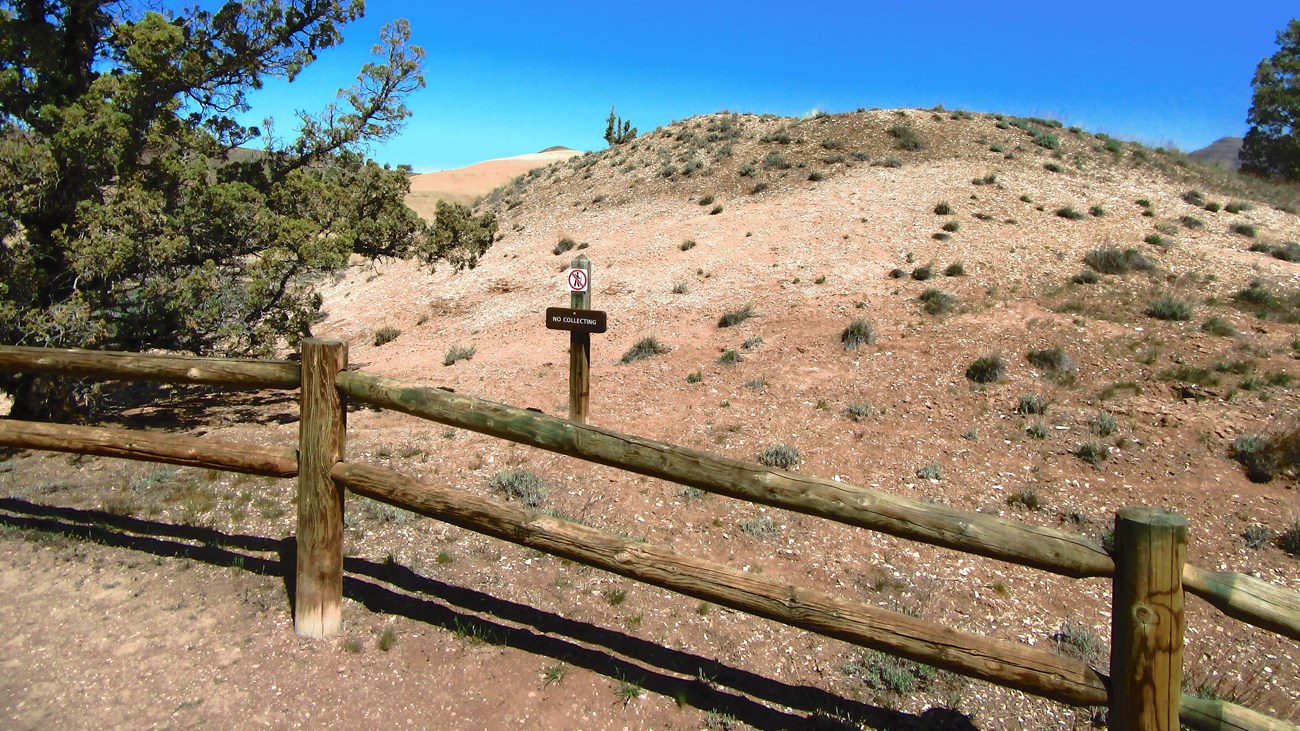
left=1240, top=18, right=1300, bottom=181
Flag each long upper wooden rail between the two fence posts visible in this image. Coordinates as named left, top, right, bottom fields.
left=338, top=371, right=1115, bottom=578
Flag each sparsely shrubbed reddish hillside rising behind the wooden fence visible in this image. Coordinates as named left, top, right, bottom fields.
left=319, top=111, right=1300, bottom=723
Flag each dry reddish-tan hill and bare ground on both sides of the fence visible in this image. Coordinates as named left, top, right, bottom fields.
left=0, top=109, right=1300, bottom=730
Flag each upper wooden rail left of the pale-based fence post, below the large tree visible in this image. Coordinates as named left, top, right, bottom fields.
left=0, top=345, right=302, bottom=390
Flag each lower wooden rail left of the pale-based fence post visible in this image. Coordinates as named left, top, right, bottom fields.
left=0, top=419, right=298, bottom=477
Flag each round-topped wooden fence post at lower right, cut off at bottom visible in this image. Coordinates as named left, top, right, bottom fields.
left=1110, top=506, right=1187, bottom=731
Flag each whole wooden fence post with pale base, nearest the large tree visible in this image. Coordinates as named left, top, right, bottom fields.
left=294, top=338, right=347, bottom=637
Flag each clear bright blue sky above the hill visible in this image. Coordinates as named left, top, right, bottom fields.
left=233, top=0, right=1300, bottom=172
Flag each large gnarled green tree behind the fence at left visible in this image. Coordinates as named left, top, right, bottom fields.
left=0, top=0, right=436, bottom=416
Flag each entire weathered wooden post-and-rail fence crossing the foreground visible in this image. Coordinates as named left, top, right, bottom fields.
left=0, top=338, right=1300, bottom=731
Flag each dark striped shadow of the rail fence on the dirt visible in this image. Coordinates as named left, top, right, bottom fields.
left=0, top=498, right=976, bottom=731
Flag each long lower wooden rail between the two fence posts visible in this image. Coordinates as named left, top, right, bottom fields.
left=333, top=462, right=1106, bottom=705
